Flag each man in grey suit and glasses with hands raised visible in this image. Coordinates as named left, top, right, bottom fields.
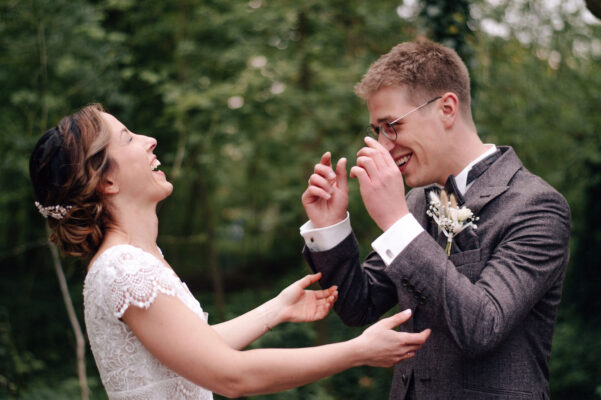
left=301, top=40, right=570, bottom=400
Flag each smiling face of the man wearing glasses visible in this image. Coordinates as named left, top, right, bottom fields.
left=367, top=87, right=448, bottom=187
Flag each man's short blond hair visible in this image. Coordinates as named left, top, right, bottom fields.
left=355, top=39, right=472, bottom=119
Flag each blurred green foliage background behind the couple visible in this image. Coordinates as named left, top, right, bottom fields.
left=0, top=0, right=601, bottom=399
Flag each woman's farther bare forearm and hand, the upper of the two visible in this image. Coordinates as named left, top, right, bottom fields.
left=213, top=273, right=338, bottom=350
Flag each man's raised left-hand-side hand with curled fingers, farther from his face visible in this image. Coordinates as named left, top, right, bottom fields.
left=302, top=152, right=348, bottom=228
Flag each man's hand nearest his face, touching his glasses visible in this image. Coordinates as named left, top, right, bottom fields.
left=350, top=137, right=409, bottom=231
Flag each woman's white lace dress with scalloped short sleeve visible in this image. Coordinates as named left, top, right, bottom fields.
left=83, top=245, right=213, bottom=400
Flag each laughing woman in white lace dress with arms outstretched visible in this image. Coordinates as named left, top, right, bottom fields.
left=29, top=105, right=430, bottom=399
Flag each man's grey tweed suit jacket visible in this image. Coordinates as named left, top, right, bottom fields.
left=303, top=146, right=570, bottom=400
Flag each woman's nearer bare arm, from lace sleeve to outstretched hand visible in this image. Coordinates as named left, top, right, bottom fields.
left=123, top=294, right=430, bottom=397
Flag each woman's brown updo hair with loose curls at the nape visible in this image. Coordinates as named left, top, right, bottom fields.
left=29, top=104, right=113, bottom=259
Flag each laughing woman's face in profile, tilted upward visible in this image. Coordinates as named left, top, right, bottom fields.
left=102, top=112, right=173, bottom=203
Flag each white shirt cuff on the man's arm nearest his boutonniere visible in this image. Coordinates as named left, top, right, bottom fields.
left=371, top=214, right=424, bottom=267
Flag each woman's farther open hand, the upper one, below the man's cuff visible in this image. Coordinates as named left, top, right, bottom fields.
left=275, top=273, right=338, bottom=322
